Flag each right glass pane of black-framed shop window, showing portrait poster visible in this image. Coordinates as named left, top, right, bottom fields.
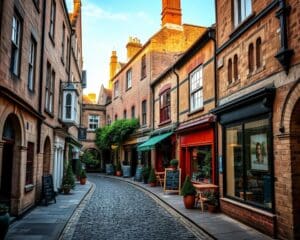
left=245, top=119, right=272, bottom=208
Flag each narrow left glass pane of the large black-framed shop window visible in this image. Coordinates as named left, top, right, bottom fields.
left=226, top=125, right=244, bottom=198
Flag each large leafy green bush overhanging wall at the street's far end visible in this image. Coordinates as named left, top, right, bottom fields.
left=96, top=119, right=139, bottom=149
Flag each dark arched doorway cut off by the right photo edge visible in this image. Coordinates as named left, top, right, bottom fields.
left=290, top=99, right=300, bottom=239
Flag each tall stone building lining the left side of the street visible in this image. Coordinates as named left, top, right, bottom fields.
left=0, top=0, right=82, bottom=216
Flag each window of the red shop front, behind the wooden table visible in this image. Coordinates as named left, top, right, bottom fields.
left=190, top=145, right=212, bottom=183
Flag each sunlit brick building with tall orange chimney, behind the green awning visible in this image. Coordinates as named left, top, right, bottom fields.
left=106, top=0, right=205, bottom=173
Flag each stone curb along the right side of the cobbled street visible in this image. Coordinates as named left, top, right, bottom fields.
left=98, top=174, right=217, bottom=239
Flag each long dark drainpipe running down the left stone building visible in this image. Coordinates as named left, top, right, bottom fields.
left=37, top=0, right=46, bottom=153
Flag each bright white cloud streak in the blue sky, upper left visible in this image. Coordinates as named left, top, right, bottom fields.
left=83, top=3, right=128, bottom=21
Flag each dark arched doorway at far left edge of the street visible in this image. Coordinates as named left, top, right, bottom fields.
left=0, top=114, right=22, bottom=209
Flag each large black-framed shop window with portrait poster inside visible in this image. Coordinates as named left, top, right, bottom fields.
left=225, top=118, right=272, bottom=209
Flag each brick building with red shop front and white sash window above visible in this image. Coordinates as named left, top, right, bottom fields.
left=151, top=28, right=217, bottom=183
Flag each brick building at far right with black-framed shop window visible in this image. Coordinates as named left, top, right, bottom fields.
left=214, top=0, right=300, bottom=239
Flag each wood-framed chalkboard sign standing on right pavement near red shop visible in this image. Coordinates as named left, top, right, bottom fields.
left=164, top=168, right=181, bottom=193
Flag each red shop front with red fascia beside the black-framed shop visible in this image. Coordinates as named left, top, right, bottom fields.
left=177, top=118, right=216, bottom=183
